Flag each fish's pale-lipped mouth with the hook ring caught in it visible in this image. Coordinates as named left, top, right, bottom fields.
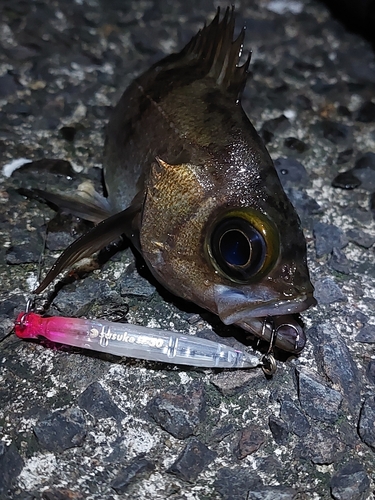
left=216, top=290, right=316, bottom=354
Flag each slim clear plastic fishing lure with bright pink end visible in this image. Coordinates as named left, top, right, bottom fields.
left=15, top=312, right=262, bottom=368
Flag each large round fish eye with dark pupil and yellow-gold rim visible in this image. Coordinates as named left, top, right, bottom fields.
left=207, top=209, right=279, bottom=282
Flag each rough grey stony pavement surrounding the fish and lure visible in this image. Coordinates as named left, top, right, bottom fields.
left=0, top=0, right=375, bottom=500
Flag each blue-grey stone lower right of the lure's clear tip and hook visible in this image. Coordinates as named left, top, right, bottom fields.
left=297, top=371, right=342, bottom=422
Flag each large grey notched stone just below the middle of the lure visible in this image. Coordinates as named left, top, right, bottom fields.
left=147, top=384, right=205, bottom=439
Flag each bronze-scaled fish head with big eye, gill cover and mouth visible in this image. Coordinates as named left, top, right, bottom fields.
left=140, top=141, right=315, bottom=352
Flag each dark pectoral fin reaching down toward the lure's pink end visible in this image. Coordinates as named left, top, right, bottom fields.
left=34, top=204, right=140, bottom=293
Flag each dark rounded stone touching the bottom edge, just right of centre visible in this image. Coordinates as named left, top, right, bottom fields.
left=214, top=467, right=263, bottom=500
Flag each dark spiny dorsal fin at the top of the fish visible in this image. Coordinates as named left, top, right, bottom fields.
left=180, top=7, right=251, bottom=96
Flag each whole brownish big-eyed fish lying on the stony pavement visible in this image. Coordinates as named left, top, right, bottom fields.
left=31, top=7, right=316, bottom=354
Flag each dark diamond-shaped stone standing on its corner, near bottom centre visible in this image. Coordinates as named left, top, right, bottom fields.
left=168, top=438, right=216, bottom=483
